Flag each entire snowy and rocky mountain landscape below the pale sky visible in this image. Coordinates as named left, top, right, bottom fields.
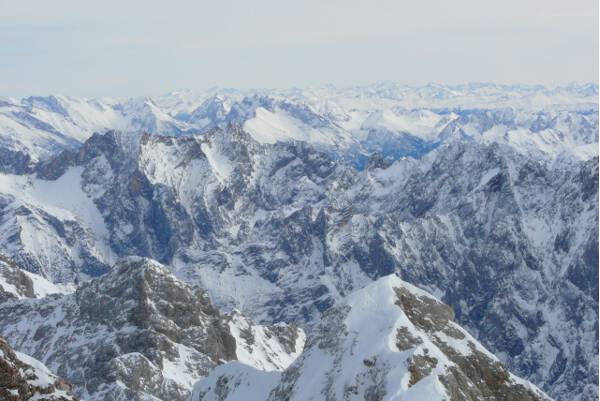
left=0, top=83, right=599, bottom=401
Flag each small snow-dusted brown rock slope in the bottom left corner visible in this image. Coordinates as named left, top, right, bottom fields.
left=0, top=337, right=77, bottom=401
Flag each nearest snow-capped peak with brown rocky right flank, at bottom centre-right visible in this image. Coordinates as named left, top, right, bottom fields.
left=191, top=275, right=550, bottom=401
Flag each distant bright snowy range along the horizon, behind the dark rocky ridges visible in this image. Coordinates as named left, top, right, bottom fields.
left=0, top=83, right=598, bottom=173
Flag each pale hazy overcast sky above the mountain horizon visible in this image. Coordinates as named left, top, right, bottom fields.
left=0, top=0, right=598, bottom=96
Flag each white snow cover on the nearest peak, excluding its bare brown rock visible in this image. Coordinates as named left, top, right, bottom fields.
left=190, top=275, right=549, bottom=401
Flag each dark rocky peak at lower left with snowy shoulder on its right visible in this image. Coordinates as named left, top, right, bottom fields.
left=0, top=258, right=303, bottom=401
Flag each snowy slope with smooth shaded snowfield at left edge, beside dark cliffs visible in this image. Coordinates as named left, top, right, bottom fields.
left=0, top=162, right=113, bottom=282
